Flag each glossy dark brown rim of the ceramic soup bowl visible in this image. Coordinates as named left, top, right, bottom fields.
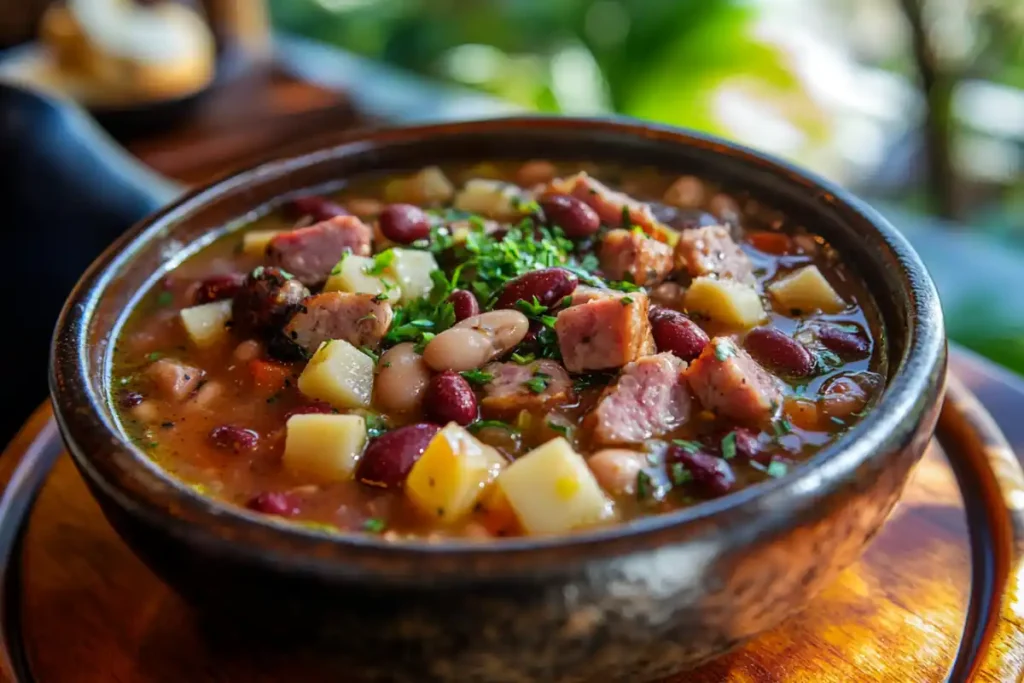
left=49, top=116, right=946, bottom=581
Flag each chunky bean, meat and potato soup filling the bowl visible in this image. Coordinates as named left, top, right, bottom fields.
left=112, top=161, right=886, bottom=540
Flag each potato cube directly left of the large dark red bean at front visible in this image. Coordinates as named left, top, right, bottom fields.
left=282, top=414, right=367, bottom=483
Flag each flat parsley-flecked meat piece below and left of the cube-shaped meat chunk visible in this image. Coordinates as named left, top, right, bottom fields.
left=480, top=359, right=573, bottom=420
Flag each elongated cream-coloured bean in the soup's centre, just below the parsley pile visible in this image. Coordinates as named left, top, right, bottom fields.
left=423, top=309, right=529, bottom=372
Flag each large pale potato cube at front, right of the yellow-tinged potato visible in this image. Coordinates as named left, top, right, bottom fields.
left=498, top=436, right=615, bottom=535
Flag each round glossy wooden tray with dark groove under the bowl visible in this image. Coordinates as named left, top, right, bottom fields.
left=0, top=360, right=1024, bottom=683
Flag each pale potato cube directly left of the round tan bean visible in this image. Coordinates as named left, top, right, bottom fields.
left=299, top=339, right=374, bottom=410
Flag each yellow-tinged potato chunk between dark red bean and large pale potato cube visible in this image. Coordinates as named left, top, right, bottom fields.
left=406, top=422, right=505, bottom=524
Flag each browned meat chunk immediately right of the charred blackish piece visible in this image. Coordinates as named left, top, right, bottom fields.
left=285, top=292, right=393, bottom=353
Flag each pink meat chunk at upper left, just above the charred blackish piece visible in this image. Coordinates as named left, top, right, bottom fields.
left=266, top=216, right=373, bottom=286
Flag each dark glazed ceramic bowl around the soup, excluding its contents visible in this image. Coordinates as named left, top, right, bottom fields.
left=51, top=118, right=945, bottom=682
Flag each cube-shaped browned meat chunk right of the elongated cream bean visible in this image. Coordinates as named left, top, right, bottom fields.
left=555, top=292, right=654, bottom=373
